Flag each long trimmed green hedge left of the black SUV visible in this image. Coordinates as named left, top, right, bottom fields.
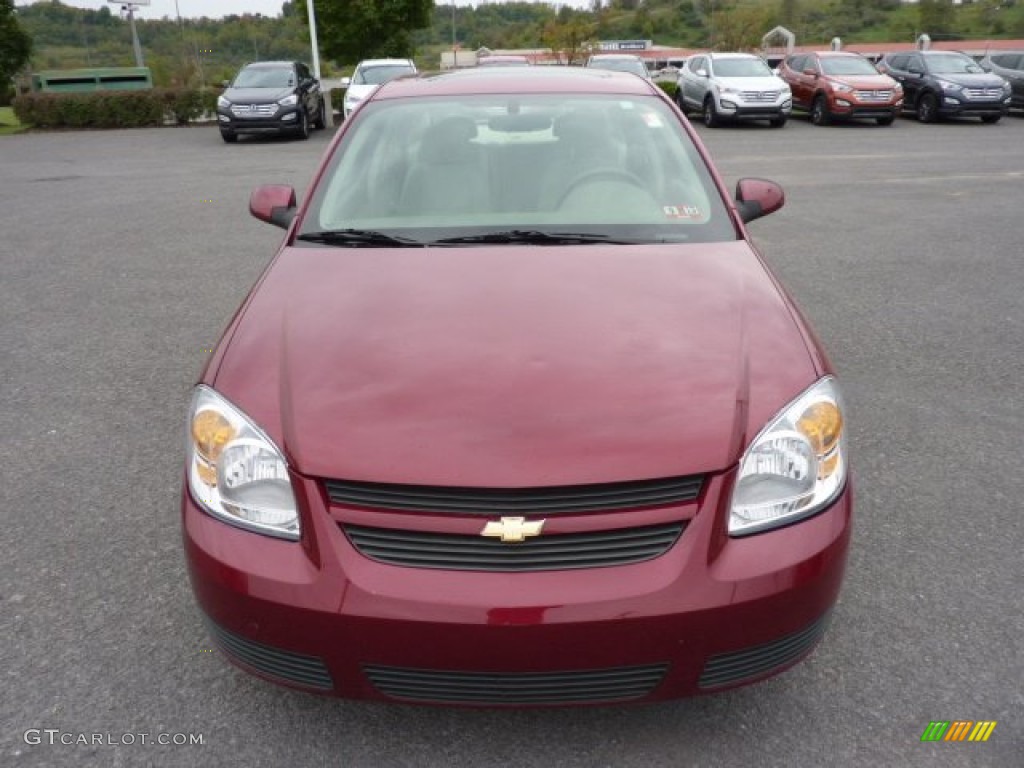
left=13, top=88, right=217, bottom=128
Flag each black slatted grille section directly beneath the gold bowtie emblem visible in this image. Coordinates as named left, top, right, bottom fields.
left=342, top=522, right=684, bottom=572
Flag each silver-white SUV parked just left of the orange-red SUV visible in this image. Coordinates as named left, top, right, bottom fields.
left=676, top=53, right=793, bottom=128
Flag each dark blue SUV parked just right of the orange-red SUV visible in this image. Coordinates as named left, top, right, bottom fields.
left=879, top=50, right=1010, bottom=123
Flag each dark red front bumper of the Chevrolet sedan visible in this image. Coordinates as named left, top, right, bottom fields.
left=182, top=473, right=852, bottom=706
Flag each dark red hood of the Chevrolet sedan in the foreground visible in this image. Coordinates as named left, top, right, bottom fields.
left=211, top=246, right=820, bottom=487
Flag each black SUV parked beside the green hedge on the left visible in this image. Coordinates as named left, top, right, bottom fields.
left=217, top=61, right=324, bottom=143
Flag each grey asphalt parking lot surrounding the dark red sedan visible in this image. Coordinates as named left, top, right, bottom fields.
left=0, top=117, right=1024, bottom=768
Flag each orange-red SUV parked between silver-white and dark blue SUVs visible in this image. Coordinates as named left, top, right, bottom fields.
left=778, top=51, right=903, bottom=125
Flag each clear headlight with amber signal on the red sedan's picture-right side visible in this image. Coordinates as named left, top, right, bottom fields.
left=729, top=376, right=848, bottom=536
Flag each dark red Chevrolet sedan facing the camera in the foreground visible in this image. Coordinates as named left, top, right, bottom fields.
left=181, top=68, right=852, bottom=706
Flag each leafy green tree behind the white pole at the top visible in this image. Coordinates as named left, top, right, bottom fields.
left=295, top=0, right=434, bottom=61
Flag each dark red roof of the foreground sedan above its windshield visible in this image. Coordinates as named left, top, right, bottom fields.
left=373, top=67, right=659, bottom=99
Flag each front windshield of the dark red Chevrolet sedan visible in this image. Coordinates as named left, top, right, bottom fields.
left=301, top=93, right=738, bottom=247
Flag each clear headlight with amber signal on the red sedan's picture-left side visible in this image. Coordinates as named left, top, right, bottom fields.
left=187, top=385, right=299, bottom=540
